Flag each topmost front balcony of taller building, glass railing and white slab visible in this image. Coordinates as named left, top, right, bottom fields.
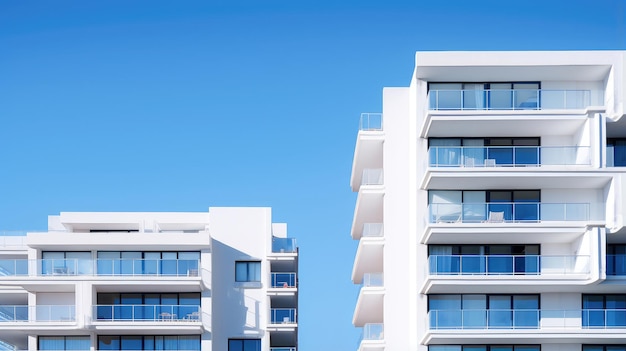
left=420, top=89, right=604, bottom=138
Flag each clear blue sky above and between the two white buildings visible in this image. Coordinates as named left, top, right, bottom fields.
left=0, top=0, right=626, bottom=351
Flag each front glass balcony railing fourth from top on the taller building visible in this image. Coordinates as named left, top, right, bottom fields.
left=428, top=255, right=590, bottom=275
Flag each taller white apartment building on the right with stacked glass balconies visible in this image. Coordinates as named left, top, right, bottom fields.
left=350, top=51, right=626, bottom=351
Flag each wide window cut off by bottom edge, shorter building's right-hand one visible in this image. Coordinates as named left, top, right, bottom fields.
left=97, top=335, right=200, bottom=351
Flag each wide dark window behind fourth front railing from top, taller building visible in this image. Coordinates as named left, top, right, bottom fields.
left=428, top=245, right=540, bottom=274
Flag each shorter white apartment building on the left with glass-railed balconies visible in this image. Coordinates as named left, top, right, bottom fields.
left=0, top=207, right=298, bottom=351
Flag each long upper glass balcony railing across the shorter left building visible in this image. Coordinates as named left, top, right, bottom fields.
left=0, top=258, right=200, bottom=277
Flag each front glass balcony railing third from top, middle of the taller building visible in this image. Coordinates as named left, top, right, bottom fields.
left=428, top=202, right=590, bottom=223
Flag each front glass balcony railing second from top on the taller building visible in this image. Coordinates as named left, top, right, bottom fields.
left=428, top=146, right=591, bottom=167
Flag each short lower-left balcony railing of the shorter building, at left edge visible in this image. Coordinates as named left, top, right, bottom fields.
left=0, top=305, right=76, bottom=322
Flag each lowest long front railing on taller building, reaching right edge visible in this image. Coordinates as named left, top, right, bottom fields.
left=427, top=309, right=626, bottom=330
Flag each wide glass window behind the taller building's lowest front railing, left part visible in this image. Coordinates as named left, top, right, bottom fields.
left=428, top=294, right=539, bottom=329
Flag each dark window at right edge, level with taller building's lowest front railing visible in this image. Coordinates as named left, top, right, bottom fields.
left=583, top=295, right=626, bottom=328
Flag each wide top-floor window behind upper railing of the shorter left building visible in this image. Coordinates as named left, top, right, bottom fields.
left=98, top=251, right=200, bottom=276
